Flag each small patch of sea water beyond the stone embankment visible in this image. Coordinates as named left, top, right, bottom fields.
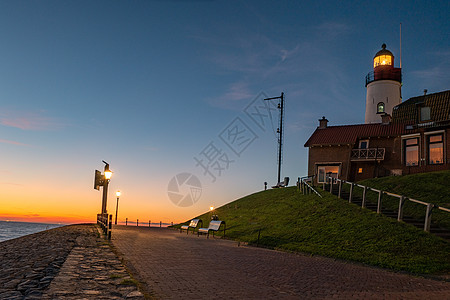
left=0, top=221, right=63, bottom=242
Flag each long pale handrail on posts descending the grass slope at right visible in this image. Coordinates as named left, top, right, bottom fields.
left=324, top=175, right=450, bottom=232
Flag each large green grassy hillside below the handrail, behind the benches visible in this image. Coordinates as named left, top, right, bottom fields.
left=175, top=187, right=450, bottom=274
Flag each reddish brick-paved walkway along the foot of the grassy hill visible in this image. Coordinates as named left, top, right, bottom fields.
left=113, top=226, right=450, bottom=300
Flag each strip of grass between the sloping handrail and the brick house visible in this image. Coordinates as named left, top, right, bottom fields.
left=359, top=171, right=450, bottom=229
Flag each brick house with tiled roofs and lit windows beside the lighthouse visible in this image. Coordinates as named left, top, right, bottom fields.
left=305, top=90, right=450, bottom=182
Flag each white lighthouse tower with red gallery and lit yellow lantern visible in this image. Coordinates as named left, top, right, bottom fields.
left=365, top=44, right=402, bottom=124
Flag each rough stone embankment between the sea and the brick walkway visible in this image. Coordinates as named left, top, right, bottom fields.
left=0, top=225, right=144, bottom=300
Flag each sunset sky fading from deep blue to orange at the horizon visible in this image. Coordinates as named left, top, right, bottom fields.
left=0, top=0, right=450, bottom=223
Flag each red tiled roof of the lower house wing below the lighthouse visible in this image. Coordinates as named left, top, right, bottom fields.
left=305, top=123, right=413, bottom=147
